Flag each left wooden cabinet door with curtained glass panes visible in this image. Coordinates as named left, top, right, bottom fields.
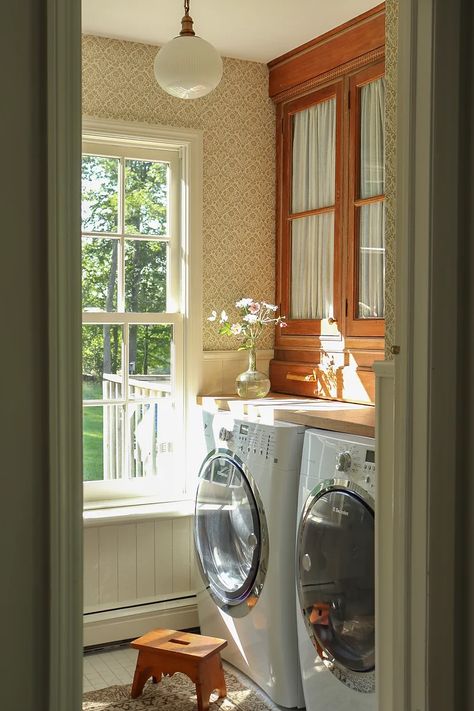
left=282, top=84, right=342, bottom=335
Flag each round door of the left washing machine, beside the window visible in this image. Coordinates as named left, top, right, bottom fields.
left=194, top=449, right=268, bottom=617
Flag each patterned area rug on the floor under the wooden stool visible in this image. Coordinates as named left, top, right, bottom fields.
left=82, top=671, right=273, bottom=711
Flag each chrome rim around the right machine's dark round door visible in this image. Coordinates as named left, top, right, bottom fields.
left=296, top=479, right=375, bottom=693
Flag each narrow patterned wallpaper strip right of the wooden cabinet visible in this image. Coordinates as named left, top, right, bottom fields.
left=385, top=0, right=398, bottom=359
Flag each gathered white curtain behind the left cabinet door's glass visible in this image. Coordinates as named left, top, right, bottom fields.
left=291, top=99, right=336, bottom=319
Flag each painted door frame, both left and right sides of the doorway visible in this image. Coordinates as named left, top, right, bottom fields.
left=46, top=0, right=469, bottom=711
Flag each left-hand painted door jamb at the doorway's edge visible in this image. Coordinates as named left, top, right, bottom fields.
left=45, top=0, right=83, bottom=711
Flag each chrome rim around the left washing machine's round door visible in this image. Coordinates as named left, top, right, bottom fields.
left=193, top=448, right=270, bottom=617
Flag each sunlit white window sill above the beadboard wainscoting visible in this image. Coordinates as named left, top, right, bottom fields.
left=82, top=499, right=194, bottom=527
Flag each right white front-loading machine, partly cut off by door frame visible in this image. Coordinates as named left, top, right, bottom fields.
left=296, top=430, right=376, bottom=711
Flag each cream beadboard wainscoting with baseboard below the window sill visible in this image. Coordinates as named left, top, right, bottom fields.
left=84, top=513, right=198, bottom=647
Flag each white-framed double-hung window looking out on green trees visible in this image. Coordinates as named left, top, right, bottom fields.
left=82, top=119, right=201, bottom=501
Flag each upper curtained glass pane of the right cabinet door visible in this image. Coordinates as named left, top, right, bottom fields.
left=360, top=77, right=385, bottom=198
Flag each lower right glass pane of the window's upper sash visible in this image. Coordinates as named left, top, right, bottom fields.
left=125, top=239, right=168, bottom=313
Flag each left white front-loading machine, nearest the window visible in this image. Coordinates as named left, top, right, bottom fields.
left=194, top=414, right=304, bottom=708
